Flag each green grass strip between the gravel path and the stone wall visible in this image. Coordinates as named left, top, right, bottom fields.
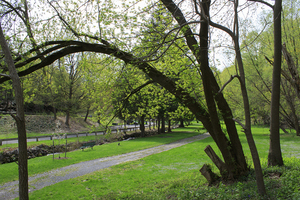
left=0, top=128, right=204, bottom=184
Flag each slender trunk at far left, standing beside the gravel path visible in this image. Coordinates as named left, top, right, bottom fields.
left=0, top=24, right=29, bottom=200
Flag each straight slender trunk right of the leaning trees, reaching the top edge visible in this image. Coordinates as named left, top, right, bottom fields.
left=268, top=0, right=283, bottom=166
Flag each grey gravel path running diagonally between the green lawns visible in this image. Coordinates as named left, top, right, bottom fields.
left=0, top=133, right=209, bottom=200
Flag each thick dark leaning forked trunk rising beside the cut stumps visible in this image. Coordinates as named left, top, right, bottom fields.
left=162, top=0, right=249, bottom=180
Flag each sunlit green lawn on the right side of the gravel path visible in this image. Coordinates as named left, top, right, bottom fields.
left=25, top=122, right=300, bottom=200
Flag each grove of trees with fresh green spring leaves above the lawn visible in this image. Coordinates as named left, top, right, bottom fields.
left=0, top=0, right=300, bottom=199
